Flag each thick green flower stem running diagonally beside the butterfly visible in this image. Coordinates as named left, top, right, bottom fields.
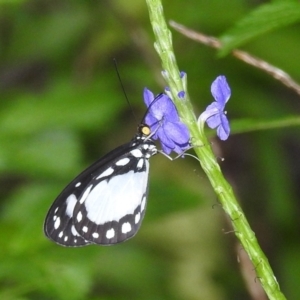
left=146, top=0, right=286, bottom=300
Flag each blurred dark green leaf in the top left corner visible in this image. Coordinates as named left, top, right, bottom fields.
left=7, top=6, right=89, bottom=61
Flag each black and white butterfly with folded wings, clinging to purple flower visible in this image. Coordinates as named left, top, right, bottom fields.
left=44, top=124, right=157, bottom=247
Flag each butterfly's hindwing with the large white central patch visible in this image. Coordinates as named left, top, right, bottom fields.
left=73, top=156, right=149, bottom=245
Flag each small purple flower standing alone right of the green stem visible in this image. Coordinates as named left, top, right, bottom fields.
left=199, top=76, right=231, bottom=141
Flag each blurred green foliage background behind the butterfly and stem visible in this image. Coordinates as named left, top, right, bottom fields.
left=0, top=0, right=300, bottom=300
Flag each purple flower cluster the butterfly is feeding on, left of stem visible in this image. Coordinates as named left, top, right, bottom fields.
left=144, top=88, right=190, bottom=154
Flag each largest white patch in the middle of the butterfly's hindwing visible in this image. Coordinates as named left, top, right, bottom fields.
left=84, top=159, right=149, bottom=225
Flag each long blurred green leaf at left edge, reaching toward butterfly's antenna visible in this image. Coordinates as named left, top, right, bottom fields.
left=0, top=80, right=121, bottom=136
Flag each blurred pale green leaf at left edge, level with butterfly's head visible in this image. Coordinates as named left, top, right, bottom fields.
left=0, top=130, right=82, bottom=178
